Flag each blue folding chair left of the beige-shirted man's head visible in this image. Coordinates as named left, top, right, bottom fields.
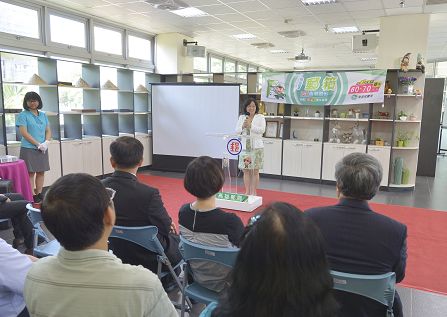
left=26, top=203, right=61, bottom=258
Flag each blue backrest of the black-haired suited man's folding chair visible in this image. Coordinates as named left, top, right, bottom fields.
left=109, top=226, right=164, bottom=255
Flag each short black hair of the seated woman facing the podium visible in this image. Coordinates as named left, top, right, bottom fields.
left=183, top=156, right=224, bottom=199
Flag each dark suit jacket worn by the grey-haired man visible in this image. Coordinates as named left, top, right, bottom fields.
left=305, top=199, right=407, bottom=317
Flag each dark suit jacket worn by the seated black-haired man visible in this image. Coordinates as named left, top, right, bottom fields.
left=102, top=171, right=178, bottom=272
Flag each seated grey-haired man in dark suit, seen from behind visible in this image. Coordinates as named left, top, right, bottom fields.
left=305, top=153, right=407, bottom=317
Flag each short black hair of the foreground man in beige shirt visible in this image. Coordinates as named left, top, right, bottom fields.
left=41, top=173, right=111, bottom=251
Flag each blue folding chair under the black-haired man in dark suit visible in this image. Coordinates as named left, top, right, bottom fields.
left=109, top=226, right=192, bottom=308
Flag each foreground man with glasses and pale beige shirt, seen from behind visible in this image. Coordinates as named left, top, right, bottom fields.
left=24, top=174, right=178, bottom=317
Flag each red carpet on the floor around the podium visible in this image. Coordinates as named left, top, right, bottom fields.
left=138, top=174, right=447, bottom=295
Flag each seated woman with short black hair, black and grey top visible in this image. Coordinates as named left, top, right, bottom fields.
left=179, top=156, right=244, bottom=292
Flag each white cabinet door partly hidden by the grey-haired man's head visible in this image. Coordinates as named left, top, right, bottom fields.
left=322, top=143, right=366, bottom=181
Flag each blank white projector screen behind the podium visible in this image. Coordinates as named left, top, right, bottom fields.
left=152, top=84, right=239, bottom=158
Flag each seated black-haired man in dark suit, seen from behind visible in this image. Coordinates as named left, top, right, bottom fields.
left=102, top=136, right=181, bottom=284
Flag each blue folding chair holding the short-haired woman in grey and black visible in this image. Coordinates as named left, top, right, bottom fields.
left=179, top=236, right=239, bottom=317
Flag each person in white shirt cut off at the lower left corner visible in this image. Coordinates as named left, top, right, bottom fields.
left=0, top=239, right=36, bottom=317
